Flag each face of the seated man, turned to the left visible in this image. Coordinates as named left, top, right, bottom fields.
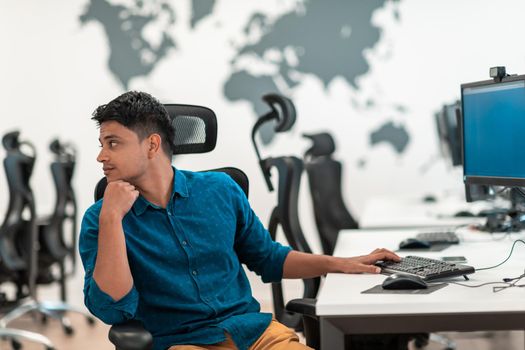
left=97, top=121, right=148, bottom=184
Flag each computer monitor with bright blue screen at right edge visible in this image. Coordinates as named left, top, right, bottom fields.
left=461, top=76, right=525, bottom=186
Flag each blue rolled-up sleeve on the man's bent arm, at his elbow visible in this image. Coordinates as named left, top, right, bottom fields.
left=79, top=203, right=139, bottom=324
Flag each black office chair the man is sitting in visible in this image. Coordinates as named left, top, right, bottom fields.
left=95, top=104, right=249, bottom=350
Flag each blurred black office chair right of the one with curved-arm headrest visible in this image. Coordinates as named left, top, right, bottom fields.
left=303, top=133, right=359, bottom=255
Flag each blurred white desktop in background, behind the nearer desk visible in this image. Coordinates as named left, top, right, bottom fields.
left=359, top=197, right=491, bottom=229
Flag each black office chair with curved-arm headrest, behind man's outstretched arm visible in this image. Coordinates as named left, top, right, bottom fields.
left=252, top=94, right=321, bottom=331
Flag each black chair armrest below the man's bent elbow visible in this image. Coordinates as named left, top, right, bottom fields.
left=108, top=321, right=153, bottom=350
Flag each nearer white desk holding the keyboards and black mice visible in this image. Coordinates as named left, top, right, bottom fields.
left=316, top=230, right=525, bottom=349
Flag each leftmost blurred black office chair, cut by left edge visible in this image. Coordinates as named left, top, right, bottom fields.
left=0, top=131, right=54, bottom=350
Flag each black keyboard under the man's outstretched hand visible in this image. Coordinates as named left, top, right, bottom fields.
left=376, top=256, right=475, bottom=281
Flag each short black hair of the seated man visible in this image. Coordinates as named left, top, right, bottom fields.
left=91, top=91, right=175, bottom=158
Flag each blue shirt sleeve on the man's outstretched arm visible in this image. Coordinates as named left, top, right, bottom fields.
left=230, top=180, right=292, bottom=283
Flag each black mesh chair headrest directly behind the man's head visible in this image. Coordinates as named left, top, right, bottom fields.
left=164, top=104, right=217, bottom=154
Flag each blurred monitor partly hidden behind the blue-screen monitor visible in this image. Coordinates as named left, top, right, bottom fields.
left=435, top=101, right=462, bottom=166
